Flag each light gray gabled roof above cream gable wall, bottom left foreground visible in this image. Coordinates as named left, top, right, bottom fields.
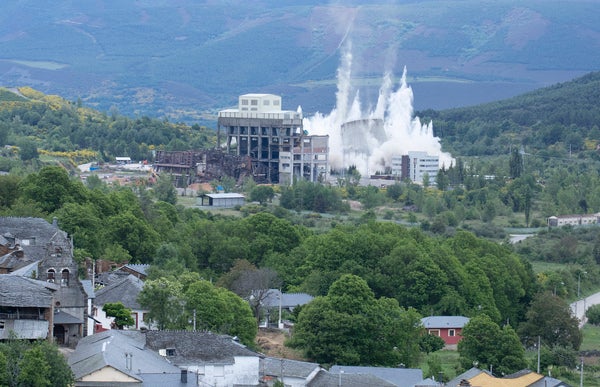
left=68, top=330, right=196, bottom=386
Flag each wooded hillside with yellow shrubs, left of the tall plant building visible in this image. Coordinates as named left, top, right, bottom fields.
left=0, top=87, right=215, bottom=161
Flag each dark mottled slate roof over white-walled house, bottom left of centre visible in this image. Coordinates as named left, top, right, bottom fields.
left=145, top=331, right=259, bottom=366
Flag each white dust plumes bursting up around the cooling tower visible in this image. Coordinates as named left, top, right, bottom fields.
left=303, top=43, right=453, bottom=176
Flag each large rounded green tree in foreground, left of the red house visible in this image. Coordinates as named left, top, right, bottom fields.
left=292, top=275, right=423, bottom=366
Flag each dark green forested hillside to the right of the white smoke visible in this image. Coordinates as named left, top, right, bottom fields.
left=424, top=72, right=600, bottom=157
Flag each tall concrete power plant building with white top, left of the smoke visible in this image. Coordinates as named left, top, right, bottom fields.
left=217, top=94, right=329, bottom=184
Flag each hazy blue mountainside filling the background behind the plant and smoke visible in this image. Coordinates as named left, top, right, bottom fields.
left=0, top=0, right=600, bottom=123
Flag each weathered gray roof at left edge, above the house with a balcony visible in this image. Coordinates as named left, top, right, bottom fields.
left=0, top=275, right=58, bottom=308
